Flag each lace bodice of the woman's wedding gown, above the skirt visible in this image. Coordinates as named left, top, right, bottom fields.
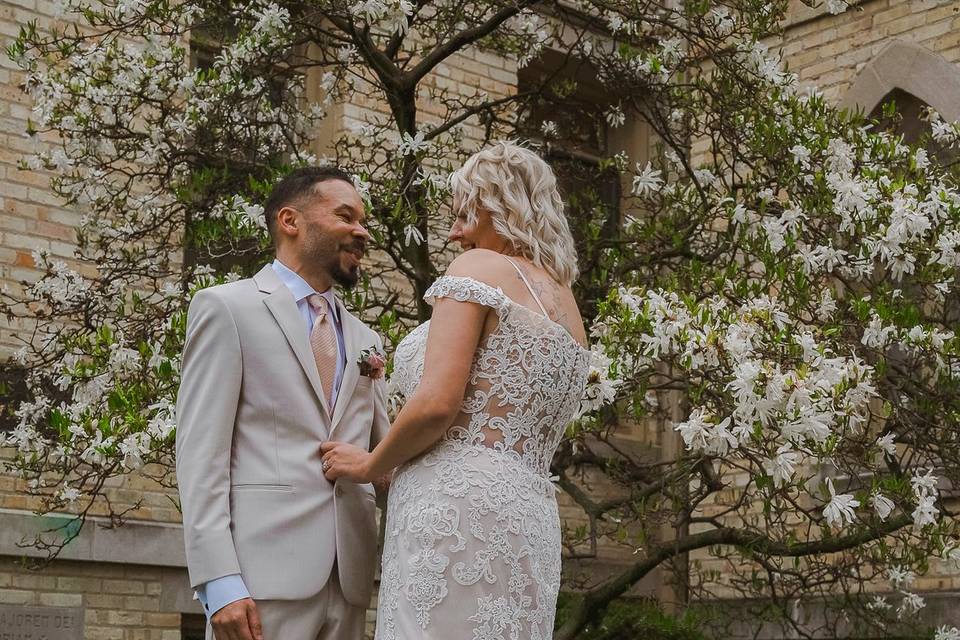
left=393, top=276, right=590, bottom=475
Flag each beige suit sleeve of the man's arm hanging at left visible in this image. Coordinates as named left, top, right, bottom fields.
left=176, top=291, right=242, bottom=587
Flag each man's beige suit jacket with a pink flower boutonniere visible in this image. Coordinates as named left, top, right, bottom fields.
left=176, top=265, right=389, bottom=607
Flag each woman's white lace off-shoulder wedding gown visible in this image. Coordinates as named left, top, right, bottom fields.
left=376, top=269, right=590, bottom=640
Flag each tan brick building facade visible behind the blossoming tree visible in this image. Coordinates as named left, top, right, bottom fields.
left=0, top=0, right=960, bottom=640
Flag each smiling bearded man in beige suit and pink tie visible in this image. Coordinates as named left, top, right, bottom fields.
left=177, top=168, right=389, bottom=640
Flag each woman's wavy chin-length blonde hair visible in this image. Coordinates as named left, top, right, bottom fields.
left=450, top=141, right=579, bottom=286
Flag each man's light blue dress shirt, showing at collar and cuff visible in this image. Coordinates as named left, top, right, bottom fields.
left=197, top=260, right=347, bottom=620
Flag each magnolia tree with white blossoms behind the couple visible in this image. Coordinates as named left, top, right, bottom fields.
left=3, top=0, right=960, bottom=640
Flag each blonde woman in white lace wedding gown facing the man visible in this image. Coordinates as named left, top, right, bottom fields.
left=323, top=143, right=589, bottom=640
